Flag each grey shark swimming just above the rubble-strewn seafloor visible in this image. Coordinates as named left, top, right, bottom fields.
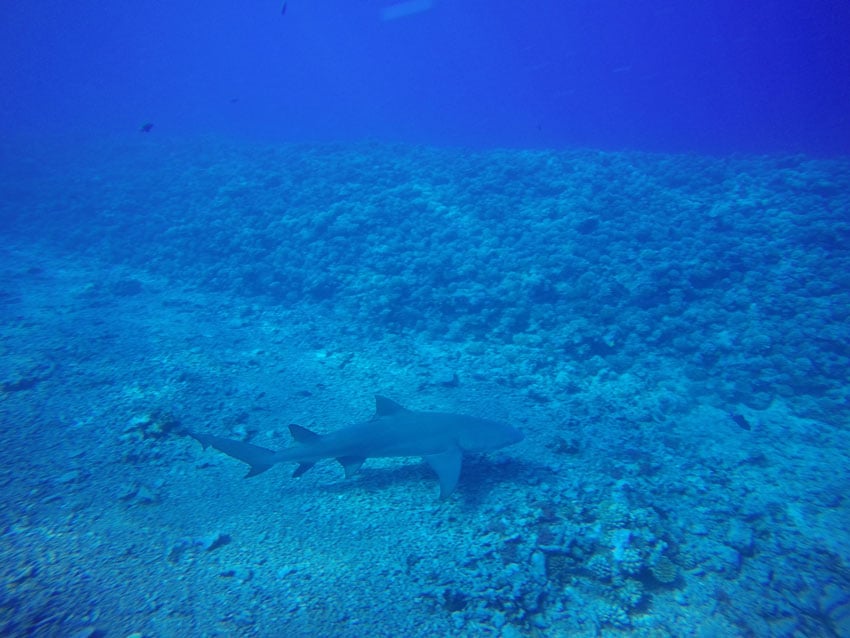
left=187, top=395, right=524, bottom=500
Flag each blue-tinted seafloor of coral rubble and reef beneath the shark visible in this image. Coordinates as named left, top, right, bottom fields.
left=0, top=136, right=850, bottom=638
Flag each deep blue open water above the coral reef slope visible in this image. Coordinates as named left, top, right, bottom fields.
left=0, top=0, right=850, bottom=154
